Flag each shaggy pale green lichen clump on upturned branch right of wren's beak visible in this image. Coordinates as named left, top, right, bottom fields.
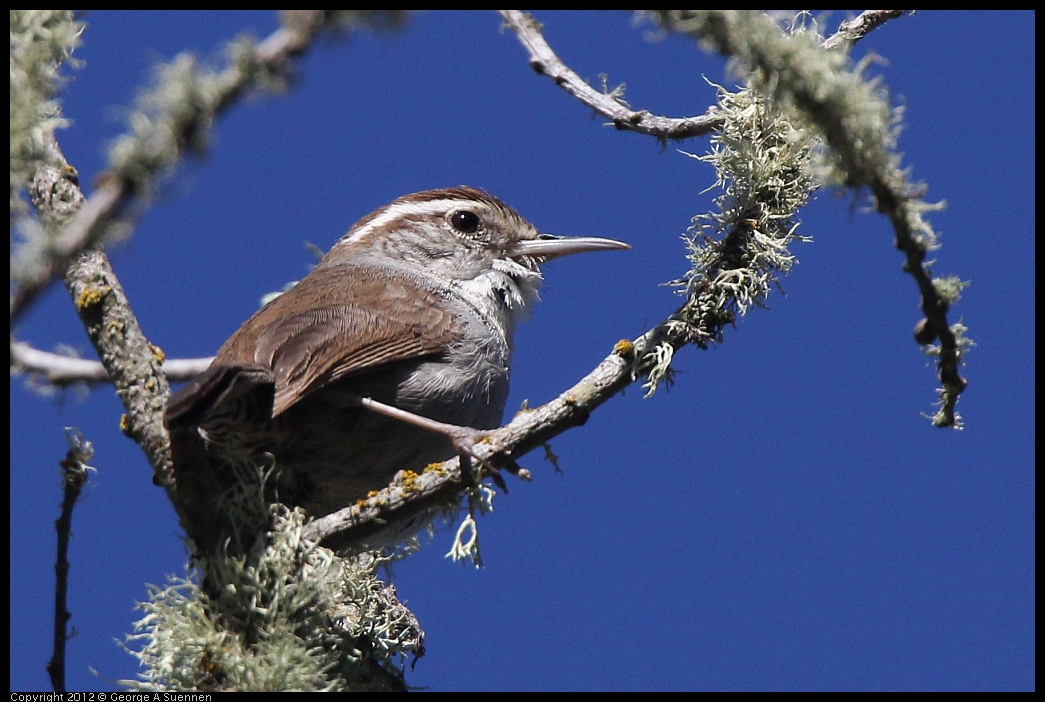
left=641, top=86, right=816, bottom=396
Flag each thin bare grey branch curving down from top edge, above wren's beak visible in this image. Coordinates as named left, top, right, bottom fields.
left=500, top=9, right=722, bottom=141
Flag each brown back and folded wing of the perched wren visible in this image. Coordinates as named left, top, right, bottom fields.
left=214, top=265, right=455, bottom=417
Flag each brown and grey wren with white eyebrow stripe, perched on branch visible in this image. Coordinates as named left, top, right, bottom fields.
left=164, top=187, right=630, bottom=532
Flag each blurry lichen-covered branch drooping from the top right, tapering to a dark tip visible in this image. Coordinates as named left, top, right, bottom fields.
left=655, top=10, right=972, bottom=428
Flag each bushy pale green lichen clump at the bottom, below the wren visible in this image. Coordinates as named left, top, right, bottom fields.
left=122, top=506, right=423, bottom=692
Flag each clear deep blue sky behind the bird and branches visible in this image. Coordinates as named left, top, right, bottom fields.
left=10, top=11, right=1035, bottom=691
